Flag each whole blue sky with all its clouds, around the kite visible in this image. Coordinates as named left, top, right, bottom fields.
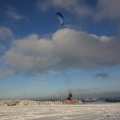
left=0, top=0, right=120, bottom=99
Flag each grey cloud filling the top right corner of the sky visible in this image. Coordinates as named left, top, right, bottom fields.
left=95, top=0, right=120, bottom=20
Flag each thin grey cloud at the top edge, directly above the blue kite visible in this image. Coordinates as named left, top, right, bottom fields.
left=36, top=0, right=92, bottom=15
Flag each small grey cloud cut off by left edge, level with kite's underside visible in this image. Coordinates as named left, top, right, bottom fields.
left=0, top=26, right=13, bottom=38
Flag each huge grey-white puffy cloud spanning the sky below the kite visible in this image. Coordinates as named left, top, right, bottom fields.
left=2, top=28, right=120, bottom=74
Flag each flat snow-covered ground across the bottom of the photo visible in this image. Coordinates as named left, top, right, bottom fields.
left=0, top=103, right=120, bottom=120
